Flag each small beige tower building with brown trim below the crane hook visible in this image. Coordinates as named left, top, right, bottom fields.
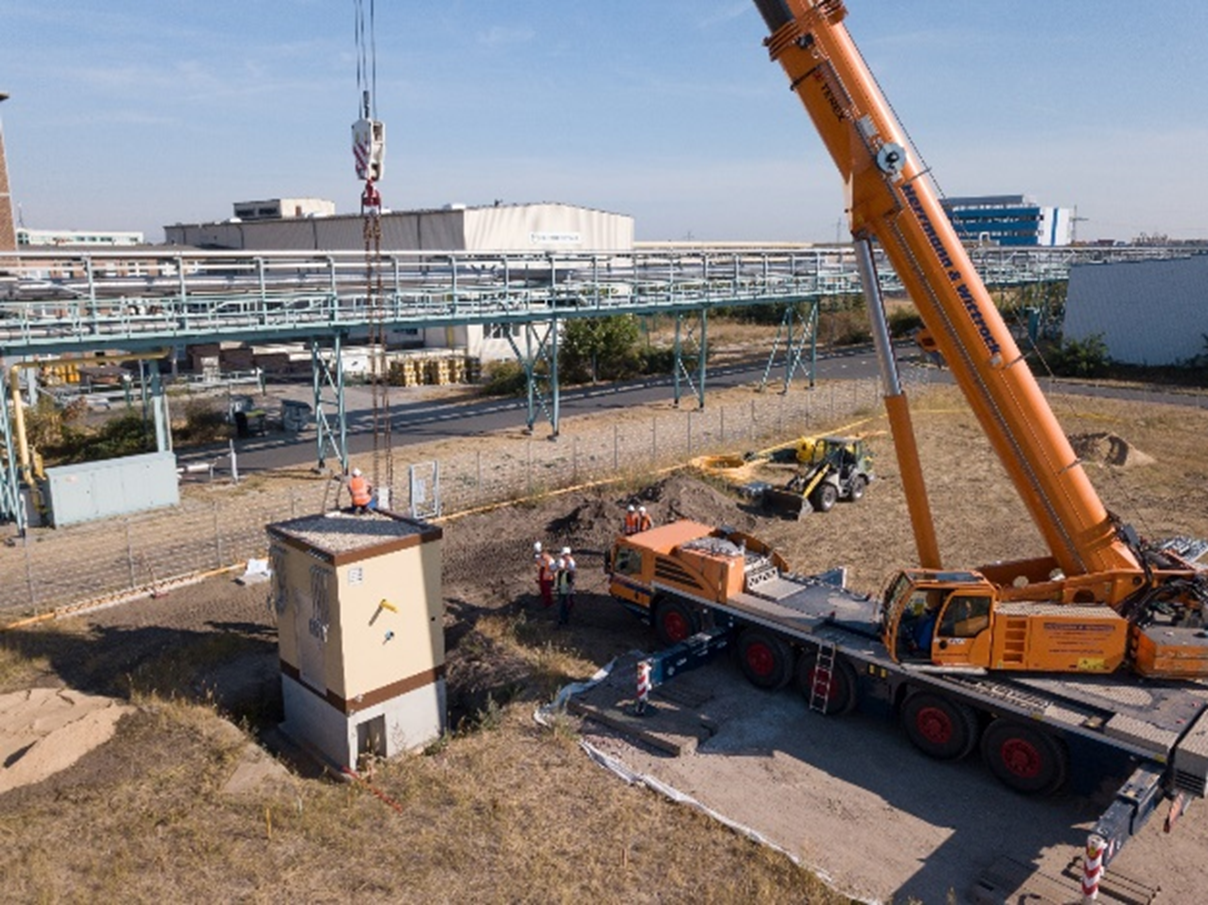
left=268, top=512, right=446, bottom=768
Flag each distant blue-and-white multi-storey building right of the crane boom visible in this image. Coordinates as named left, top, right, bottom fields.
left=941, top=195, right=1074, bottom=248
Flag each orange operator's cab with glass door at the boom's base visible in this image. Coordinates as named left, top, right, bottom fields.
left=882, top=569, right=994, bottom=666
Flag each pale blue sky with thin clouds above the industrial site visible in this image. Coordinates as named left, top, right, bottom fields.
left=0, top=0, right=1208, bottom=242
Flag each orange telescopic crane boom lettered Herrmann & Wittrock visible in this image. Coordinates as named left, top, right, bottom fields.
left=756, top=0, right=1140, bottom=575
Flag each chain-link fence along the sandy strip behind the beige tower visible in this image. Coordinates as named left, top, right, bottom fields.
left=0, top=370, right=929, bottom=617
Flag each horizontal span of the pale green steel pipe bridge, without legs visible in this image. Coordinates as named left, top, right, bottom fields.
left=0, top=245, right=1159, bottom=356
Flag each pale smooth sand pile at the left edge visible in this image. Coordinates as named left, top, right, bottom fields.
left=0, top=688, right=134, bottom=794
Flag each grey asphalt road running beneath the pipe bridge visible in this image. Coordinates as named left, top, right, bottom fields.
left=179, top=348, right=1208, bottom=472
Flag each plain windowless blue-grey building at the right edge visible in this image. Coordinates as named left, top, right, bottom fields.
left=1064, top=255, right=1208, bottom=365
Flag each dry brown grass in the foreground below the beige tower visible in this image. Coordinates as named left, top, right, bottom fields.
left=0, top=657, right=846, bottom=903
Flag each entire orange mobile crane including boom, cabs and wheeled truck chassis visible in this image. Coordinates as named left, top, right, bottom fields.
left=606, top=0, right=1208, bottom=866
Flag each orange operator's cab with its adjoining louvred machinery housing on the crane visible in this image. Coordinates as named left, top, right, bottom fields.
left=882, top=569, right=1129, bottom=673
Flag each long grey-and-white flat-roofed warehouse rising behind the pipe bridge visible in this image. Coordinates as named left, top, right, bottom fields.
left=163, top=198, right=633, bottom=254
